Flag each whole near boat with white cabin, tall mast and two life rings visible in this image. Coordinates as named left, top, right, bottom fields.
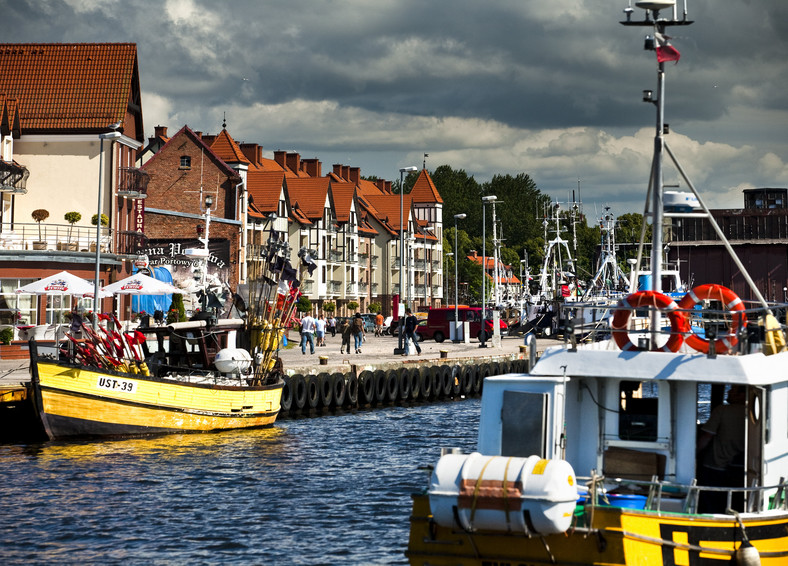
left=406, top=0, right=788, bottom=566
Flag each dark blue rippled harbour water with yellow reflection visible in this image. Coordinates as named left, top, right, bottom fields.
left=0, top=399, right=479, bottom=565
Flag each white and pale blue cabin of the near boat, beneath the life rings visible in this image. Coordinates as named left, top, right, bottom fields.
left=478, top=341, right=788, bottom=516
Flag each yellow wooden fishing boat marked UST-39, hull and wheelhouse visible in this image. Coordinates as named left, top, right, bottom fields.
left=30, top=319, right=284, bottom=439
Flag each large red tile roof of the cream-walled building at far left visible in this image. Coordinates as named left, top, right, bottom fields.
left=0, top=43, right=143, bottom=137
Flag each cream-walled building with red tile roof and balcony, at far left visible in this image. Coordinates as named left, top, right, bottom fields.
left=0, top=43, right=147, bottom=336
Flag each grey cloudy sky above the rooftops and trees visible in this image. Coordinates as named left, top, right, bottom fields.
left=0, top=0, right=788, bottom=218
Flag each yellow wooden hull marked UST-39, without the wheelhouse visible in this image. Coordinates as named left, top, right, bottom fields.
left=31, top=360, right=283, bottom=439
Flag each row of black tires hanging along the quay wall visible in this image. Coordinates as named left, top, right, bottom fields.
left=280, top=360, right=528, bottom=416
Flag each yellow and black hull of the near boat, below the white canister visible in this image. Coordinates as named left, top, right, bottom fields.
left=406, top=494, right=788, bottom=566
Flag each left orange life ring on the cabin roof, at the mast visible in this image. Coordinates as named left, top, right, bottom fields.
left=610, top=291, right=689, bottom=352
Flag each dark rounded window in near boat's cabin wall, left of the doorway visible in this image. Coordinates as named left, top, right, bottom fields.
left=618, top=381, right=659, bottom=442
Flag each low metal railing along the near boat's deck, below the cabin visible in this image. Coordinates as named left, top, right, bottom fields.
left=577, top=475, right=788, bottom=515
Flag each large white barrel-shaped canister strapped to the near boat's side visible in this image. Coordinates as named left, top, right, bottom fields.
left=429, top=452, right=577, bottom=535
